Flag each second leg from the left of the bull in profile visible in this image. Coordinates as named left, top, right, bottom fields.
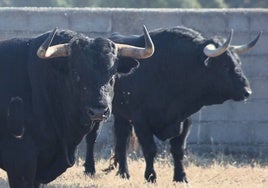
left=114, top=116, right=132, bottom=178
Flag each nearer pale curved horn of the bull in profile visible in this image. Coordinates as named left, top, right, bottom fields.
left=203, top=30, right=233, bottom=57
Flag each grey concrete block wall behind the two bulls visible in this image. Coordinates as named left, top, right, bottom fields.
left=0, top=8, right=268, bottom=154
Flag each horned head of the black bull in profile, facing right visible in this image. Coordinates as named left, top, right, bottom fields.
left=203, top=31, right=261, bottom=100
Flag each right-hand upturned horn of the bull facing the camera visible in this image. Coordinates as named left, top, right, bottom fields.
left=115, top=26, right=154, bottom=59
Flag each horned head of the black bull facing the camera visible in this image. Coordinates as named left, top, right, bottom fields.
left=37, top=26, right=154, bottom=125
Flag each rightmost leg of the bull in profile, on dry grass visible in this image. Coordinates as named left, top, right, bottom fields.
left=170, top=118, right=192, bottom=183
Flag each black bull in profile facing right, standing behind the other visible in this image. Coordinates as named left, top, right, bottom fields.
left=85, top=27, right=260, bottom=182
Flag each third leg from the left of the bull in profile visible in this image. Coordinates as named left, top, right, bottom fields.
left=134, top=126, right=157, bottom=183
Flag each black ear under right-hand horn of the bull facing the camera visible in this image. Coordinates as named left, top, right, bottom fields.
left=117, top=57, right=140, bottom=75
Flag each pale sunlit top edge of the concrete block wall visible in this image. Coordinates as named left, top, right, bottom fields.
left=0, top=7, right=268, bottom=13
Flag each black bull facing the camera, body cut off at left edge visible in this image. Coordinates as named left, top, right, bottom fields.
left=0, top=27, right=154, bottom=188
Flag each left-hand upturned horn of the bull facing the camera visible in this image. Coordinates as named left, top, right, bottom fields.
left=37, top=28, right=71, bottom=59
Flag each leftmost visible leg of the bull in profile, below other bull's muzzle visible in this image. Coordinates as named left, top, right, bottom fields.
left=84, top=123, right=100, bottom=175
